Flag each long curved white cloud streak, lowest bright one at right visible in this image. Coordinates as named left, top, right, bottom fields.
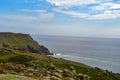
left=54, top=9, right=120, bottom=20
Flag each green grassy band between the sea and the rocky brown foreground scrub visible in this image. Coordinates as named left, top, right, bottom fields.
left=0, top=48, right=120, bottom=80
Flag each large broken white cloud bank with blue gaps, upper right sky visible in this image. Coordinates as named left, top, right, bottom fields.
left=47, top=0, right=120, bottom=19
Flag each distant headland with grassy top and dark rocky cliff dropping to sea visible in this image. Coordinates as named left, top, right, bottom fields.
left=0, top=32, right=50, bottom=55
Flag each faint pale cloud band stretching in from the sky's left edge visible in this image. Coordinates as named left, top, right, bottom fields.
left=0, top=13, right=54, bottom=22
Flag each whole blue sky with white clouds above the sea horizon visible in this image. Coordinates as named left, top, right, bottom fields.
left=0, top=0, right=120, bottom=38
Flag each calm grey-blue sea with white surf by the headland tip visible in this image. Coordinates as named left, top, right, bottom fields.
left=33, top=36, right=120, bottom=72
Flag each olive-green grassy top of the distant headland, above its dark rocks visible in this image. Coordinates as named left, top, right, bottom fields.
left=0, top=33, right=39, bottom=48
